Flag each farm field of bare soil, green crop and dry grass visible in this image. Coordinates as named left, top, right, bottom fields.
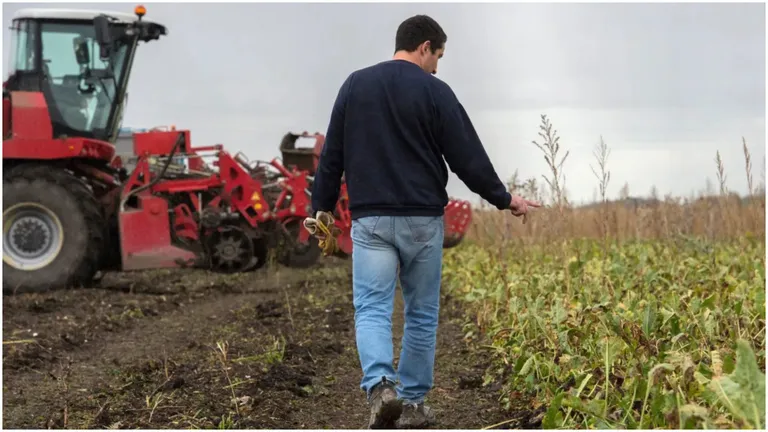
left=3, top=117, right=766, bottom=429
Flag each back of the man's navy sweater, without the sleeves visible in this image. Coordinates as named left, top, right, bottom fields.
left=343, top=60, right=448, bottom=218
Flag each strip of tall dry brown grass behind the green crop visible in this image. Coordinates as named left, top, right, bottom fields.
left=467, top=115, right=765, bottom=246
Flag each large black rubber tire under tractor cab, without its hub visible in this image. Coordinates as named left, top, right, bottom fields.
left=3, top=164, right=106, bottom=292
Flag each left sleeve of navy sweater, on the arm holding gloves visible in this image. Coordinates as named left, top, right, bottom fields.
left=312, top=75, right=352, bottom=212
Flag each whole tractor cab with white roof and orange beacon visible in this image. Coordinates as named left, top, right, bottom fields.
left=3, top=6, right=166, bottom=142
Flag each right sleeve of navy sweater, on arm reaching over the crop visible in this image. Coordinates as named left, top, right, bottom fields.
left=437, top=92, right=512, bottom=210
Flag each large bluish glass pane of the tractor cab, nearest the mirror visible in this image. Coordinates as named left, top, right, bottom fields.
left=41, top=23, right=127, bottom=135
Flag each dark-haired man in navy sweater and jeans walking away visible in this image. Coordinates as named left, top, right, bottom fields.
left=312, top=15, right=539, bottom=429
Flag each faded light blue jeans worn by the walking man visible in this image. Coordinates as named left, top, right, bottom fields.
left=352, top=216, right=444, bottom=403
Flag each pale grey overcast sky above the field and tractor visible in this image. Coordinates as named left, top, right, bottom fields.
left=3, top=3, right=766, bottom=201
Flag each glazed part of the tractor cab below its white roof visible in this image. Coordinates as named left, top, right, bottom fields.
left=8, top=19, right=136, bottom=141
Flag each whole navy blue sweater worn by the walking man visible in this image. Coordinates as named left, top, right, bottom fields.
left=312, top=60, right=511, bottom=219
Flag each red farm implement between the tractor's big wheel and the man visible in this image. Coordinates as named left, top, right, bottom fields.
left=118, top=126, right=326, bottom=272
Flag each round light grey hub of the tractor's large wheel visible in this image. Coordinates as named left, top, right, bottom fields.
left=3, top=203, right=64, bottom=271
